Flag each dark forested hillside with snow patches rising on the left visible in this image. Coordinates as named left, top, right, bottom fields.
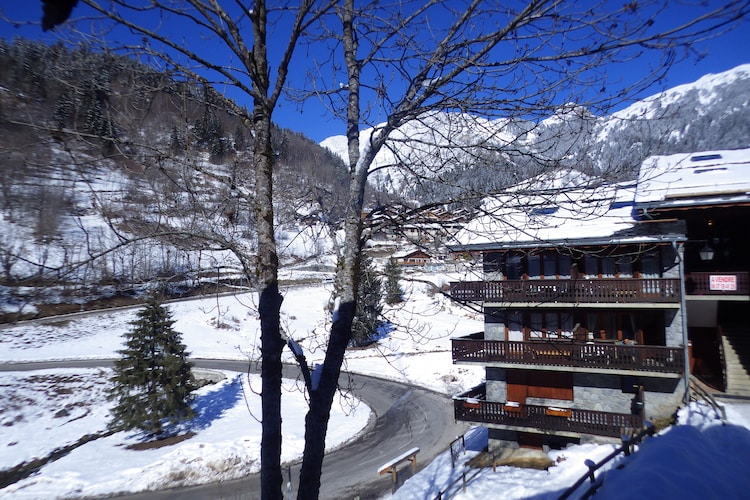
left=0, top=39, right=354, bottom=308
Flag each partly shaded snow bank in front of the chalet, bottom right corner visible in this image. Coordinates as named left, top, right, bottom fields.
left=393, top=402, right=750, bottom=500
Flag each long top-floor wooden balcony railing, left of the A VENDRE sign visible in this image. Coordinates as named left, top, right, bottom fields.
left=451, top=278, right=680, bottom=303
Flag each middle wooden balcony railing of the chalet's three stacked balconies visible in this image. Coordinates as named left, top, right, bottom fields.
left=451, top=334, right=685, bottom=373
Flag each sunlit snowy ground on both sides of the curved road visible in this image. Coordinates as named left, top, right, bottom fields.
left=0, top=272, right=482, bottom=499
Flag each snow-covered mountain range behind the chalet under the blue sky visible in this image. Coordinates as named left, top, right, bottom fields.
left=320, top=65, right=750, bottom=201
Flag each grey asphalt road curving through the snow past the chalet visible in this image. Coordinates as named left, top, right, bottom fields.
left=0, top=360, right=468, bottom=500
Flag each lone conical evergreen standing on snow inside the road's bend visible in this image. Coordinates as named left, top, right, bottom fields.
left=109, top=294, right=195, bottom=434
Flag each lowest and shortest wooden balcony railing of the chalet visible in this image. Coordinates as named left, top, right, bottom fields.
left=453, top=399, right=643, bottom=437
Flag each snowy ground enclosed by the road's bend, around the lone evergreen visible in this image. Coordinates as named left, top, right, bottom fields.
left=0, top=369, right=369, bottom=498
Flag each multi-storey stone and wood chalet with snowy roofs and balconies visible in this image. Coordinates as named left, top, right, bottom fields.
left=451, top=150, right=750, bottom=448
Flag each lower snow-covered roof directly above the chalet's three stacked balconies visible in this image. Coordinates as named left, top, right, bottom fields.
left=451, top=180, right=683, bottom=250
